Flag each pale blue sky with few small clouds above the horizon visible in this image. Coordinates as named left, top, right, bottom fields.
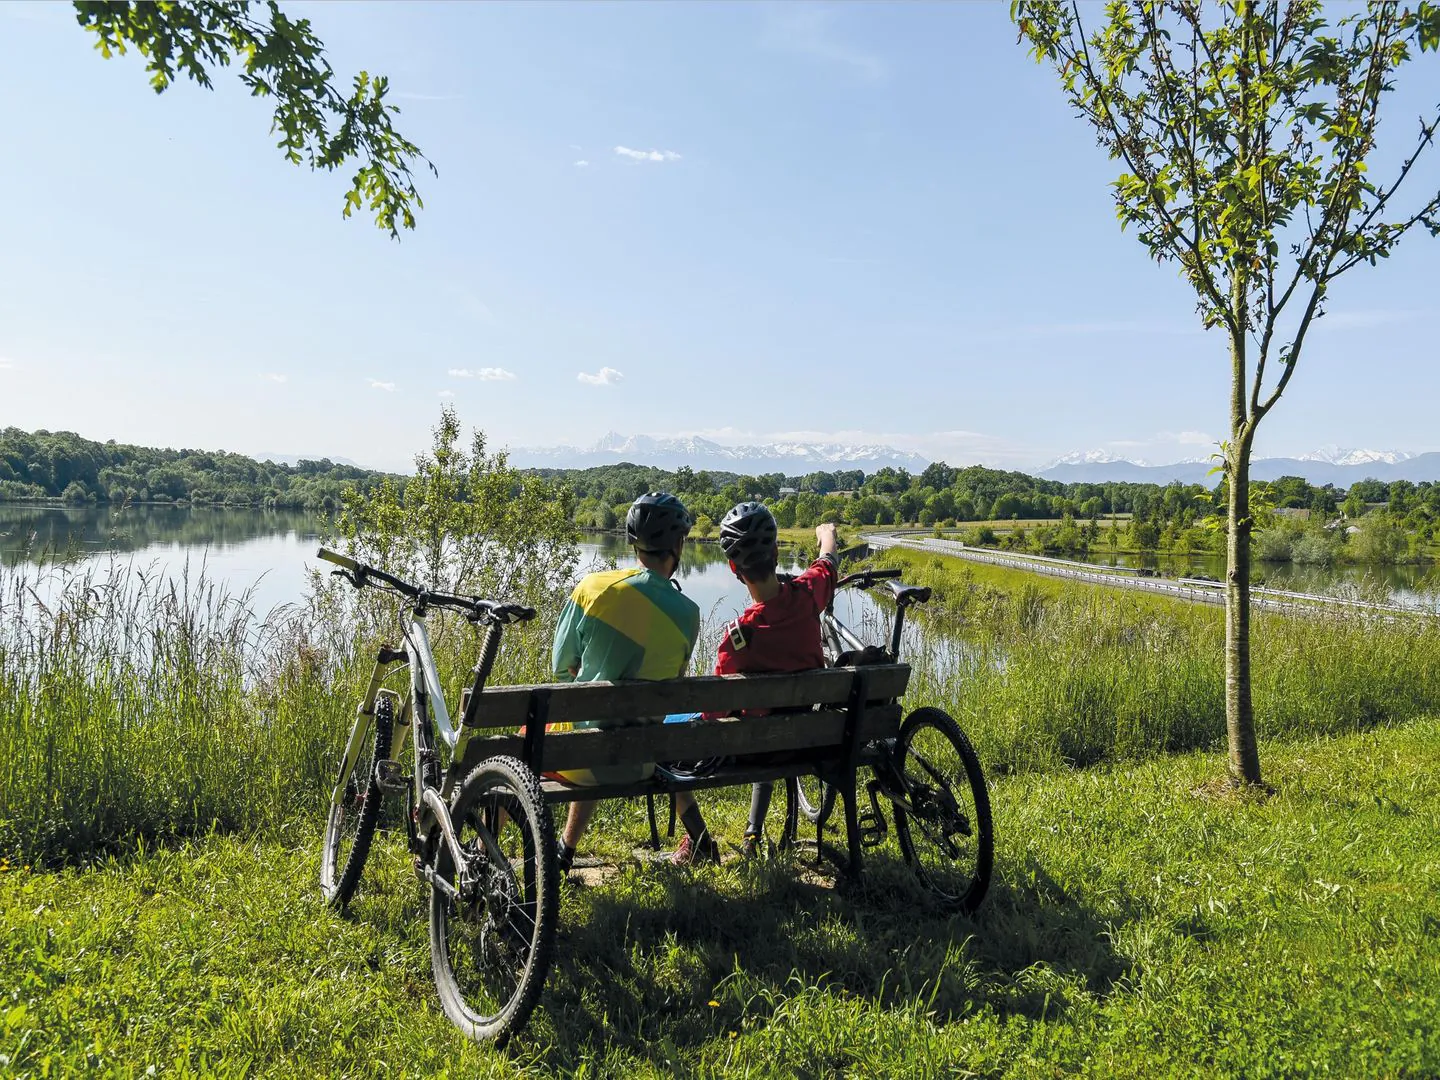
left=0, top=3, right=1440, bottom=467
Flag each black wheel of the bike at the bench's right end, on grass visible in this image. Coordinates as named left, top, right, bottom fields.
left=891, top=708, right=995, bottom=914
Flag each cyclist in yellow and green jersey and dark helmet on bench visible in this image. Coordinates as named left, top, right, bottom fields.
left=552, top=491, right=720, bottom=873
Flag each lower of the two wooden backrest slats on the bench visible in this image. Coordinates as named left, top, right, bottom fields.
left=461, top=704, right=900, bottom=772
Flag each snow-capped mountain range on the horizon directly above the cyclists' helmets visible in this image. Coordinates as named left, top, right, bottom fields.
left=510, top=432, right=930, bottom=477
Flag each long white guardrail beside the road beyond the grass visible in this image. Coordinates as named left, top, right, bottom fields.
left=860, top=533, right=1434, bottom=615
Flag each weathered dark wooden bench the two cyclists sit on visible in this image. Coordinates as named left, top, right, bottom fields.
left=451, top=664, right=910, bottom=874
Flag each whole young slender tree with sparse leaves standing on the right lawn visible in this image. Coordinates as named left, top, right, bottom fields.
left=1011, top=0, right=1440, bottom=785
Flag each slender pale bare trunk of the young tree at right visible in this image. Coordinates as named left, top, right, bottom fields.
left=1225, top=364, right=1260, bottom=785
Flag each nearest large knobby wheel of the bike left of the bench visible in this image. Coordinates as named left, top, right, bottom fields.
left=431, top=756, right=560, bottom=1045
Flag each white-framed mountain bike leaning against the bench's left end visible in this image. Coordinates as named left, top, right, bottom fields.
left=318, top=549, right=559, bottom=1043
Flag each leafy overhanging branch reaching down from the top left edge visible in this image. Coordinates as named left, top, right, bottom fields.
left=75, top=0, right=435, bottom=238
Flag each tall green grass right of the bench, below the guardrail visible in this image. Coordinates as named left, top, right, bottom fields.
left=881, top=553, right=1440, bottom=772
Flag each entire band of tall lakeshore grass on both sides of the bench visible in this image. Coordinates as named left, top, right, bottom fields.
left=11, top=553, right=1440, bottom=863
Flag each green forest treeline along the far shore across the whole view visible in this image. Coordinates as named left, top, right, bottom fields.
left=0, top=428, right=1440, bottom=562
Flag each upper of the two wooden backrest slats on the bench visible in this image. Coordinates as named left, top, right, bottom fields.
left=475, top=664, right=910, bottom=731
